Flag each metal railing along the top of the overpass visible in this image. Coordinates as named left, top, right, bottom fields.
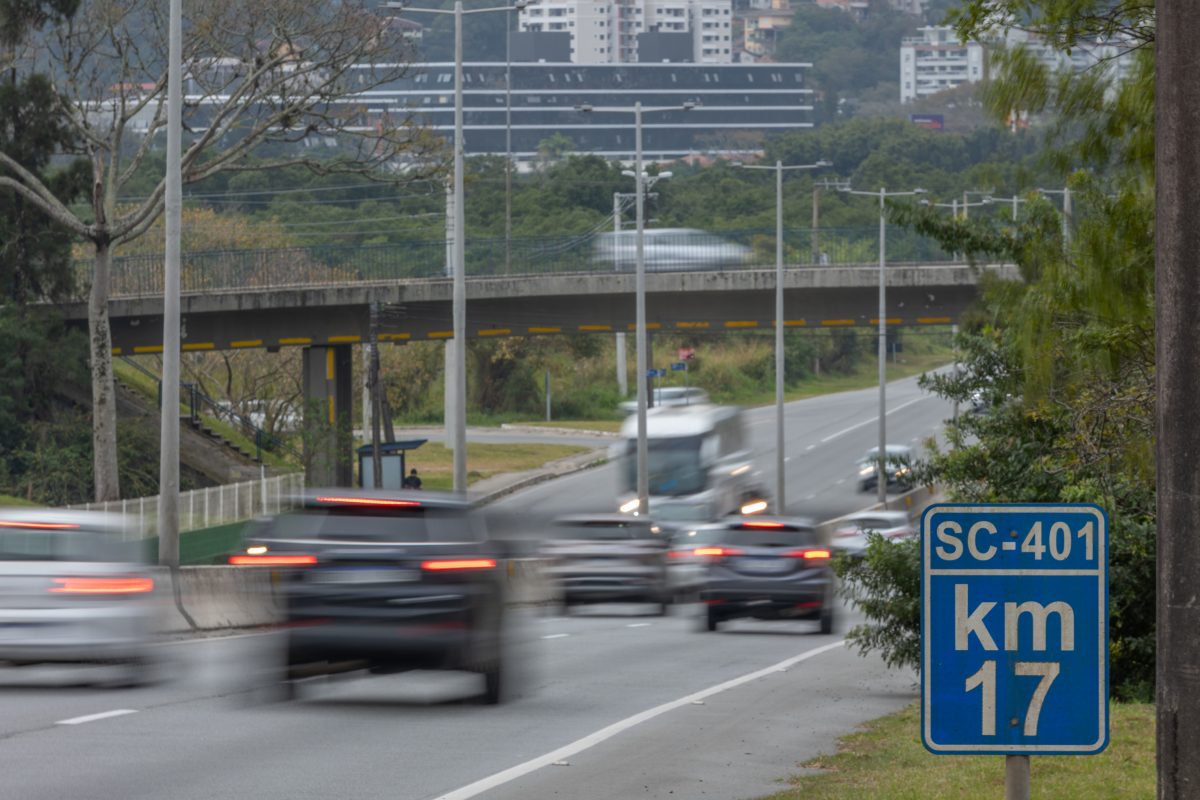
left=77, top=227, right=974, bottom=299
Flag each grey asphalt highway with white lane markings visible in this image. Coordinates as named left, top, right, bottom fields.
left=0, top=381, right=948, bottom=800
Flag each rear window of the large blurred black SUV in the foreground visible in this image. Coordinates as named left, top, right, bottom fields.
left=271, top=507, right=482, bottom=542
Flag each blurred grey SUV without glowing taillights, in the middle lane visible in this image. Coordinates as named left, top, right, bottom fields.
left=540, top=513, right=672, bottom=614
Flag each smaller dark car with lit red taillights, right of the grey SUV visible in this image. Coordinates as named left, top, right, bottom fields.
left=694, top=517, right=834, bottom=633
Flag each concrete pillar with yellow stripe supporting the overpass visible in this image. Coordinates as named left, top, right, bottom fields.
left=304, top=344, right=354, bottom=486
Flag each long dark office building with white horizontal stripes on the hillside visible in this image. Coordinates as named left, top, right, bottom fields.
left=355, top=62, right=814, bottom=160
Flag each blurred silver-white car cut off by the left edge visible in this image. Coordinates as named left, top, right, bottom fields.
left=0, top=509, right=158, bottom=685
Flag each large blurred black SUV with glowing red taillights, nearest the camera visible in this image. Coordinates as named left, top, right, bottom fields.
left=230, top=489, right=506, bottom=704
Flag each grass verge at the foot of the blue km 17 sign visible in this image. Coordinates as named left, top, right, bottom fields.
left=769, top=703, right=1156, bottom=800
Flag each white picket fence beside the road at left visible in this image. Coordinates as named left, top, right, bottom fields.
left=70, top=473, right=305, bottom=540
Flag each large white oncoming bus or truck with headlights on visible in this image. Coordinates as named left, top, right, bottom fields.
left=614, top=404, right=767, bottom=522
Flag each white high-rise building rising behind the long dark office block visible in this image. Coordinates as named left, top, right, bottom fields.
left=514, top=0, right=733, bottom=64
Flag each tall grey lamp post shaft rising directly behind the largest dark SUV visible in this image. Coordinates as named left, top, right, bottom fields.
left=452, top=0, right=467, bottom=492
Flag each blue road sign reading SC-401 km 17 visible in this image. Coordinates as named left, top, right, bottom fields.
left=920, top=504, right=1109, bottom=756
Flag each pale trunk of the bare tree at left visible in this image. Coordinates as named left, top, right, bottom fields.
left=88, top=242, right=121, bottom=503
